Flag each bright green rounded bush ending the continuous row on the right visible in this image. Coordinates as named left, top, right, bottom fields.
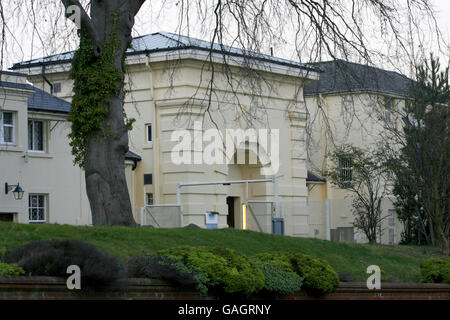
left=255, top=252, right=339, bottom=296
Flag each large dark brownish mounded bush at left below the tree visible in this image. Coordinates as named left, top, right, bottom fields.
left=3, top=240, right=123, bottom=289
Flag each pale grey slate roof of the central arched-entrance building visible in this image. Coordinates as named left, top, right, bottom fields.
left=11, top=32, right=317, bottom=71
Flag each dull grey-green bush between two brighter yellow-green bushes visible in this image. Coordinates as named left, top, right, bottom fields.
left=255, top=260, right=303, bottom=295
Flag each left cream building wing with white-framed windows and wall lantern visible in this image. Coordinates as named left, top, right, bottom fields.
left=0, top=71, right=139, bottom=225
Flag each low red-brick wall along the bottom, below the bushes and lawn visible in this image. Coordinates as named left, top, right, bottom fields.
left=0, top=277, right=450, bottom=300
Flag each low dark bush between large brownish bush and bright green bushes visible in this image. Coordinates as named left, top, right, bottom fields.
left=126, top=255, right=208, bottom=294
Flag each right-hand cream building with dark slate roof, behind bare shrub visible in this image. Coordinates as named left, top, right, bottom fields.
left=305, top=60, right=410, bottom=244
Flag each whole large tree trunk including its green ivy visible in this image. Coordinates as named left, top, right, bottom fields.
left=61, top=0, right=145, bottom=225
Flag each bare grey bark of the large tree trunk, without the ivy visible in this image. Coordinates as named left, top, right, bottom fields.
left=61, top=0, right=145, bottom=226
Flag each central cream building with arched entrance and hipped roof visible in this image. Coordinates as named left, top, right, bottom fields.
left=12, top=32, right=318, bottom=236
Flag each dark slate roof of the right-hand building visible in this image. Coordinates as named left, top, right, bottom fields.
left=304, top=60, right=412, bottom=97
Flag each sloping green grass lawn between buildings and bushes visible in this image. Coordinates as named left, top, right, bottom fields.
left=0, top=222, right=439, bottom=282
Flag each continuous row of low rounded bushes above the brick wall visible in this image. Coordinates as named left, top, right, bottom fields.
left=0, top=240, right=342, bottom=296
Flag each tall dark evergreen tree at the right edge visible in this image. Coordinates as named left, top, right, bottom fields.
left=387, top=56, right=450, bottom=255
